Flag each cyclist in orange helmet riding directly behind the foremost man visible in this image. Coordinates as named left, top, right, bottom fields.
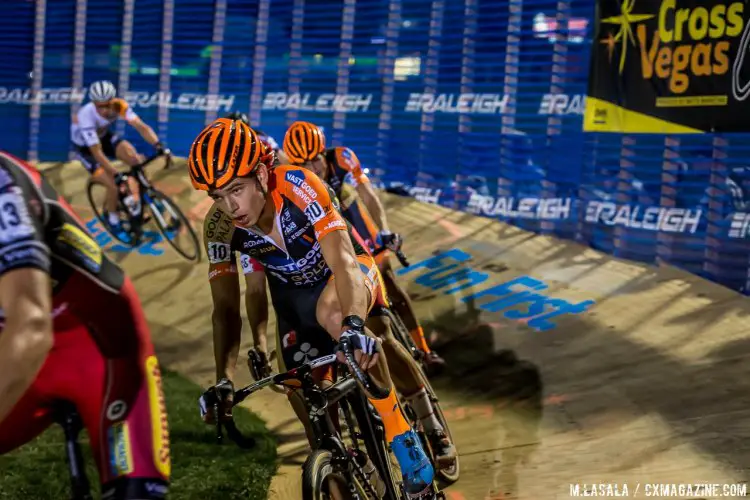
left=284, top=121, right=445, bottom=372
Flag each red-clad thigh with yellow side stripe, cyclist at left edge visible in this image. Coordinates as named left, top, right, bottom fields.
left=71, top=277, right=171, bottom=500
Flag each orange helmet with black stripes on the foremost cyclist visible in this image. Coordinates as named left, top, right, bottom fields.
left=188, top=118, right=267, bottom=191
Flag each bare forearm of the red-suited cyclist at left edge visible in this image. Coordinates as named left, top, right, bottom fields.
left=0, top=325, right=52, bottom=422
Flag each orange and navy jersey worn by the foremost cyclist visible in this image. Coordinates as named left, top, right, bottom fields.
left=205, top=166, right=366, bottom=288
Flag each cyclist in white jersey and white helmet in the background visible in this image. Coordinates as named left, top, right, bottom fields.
left=70, top=80, right=170, bottom=231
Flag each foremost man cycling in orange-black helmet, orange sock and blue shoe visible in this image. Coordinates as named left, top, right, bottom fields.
left=188, top=118, right=434, bottom=496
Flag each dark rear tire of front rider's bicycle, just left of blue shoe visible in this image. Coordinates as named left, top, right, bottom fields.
left=349, top=391, right=402, bottom=500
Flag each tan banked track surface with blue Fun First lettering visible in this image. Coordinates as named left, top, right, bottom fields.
left=41, top=164, right=750, bottom=500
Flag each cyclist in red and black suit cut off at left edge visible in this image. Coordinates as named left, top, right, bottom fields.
left=0, top=153, right=171, bottom=500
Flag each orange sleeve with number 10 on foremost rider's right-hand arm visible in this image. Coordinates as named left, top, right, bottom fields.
left=275, top=167, right=346, bottom=241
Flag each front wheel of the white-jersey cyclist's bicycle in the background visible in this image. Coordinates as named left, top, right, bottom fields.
left=143, top=189, right=201, bottom=262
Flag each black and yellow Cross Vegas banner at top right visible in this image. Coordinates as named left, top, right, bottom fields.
left=584, top=0, right=750, bottom=134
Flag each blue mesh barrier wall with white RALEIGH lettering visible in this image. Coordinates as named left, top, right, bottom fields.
left=0, top=0, right=750, bottom=292
